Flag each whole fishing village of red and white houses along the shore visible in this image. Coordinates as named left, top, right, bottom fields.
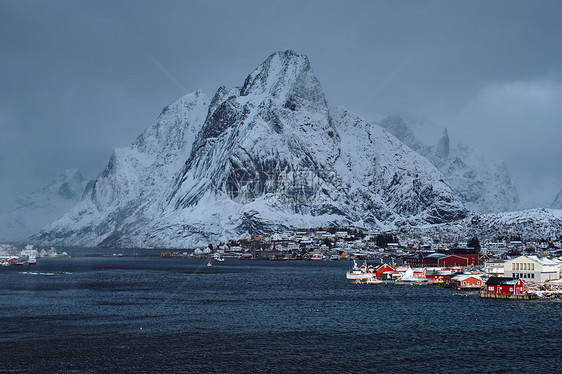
left=176, top=228, right=562, bottom=300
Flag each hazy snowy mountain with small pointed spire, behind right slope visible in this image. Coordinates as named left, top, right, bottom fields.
left=379, top=116, right=519, bottom=213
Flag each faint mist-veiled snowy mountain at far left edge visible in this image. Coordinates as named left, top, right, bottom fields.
left=0, top=169, right=87, bottom=242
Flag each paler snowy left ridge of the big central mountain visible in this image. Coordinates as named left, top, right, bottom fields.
left=38, top=91, right=210, bottom=247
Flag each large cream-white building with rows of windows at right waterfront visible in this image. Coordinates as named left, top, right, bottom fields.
left=504, top=256, right=560, bottom=282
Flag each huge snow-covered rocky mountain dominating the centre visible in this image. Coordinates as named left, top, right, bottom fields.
left=35, top=51, right=467, bottom=247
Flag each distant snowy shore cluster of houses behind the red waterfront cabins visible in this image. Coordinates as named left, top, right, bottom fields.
left=190, top=227, right=562, bottom=267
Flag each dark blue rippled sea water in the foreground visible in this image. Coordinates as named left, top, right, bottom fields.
left=0, top=257, right=562, bottom=373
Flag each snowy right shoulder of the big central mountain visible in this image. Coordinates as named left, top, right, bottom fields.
left=332, top=108, right=465, bottom=225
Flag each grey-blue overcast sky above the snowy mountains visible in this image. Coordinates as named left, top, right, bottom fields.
left=0, top=0, right=562, bottom=206
